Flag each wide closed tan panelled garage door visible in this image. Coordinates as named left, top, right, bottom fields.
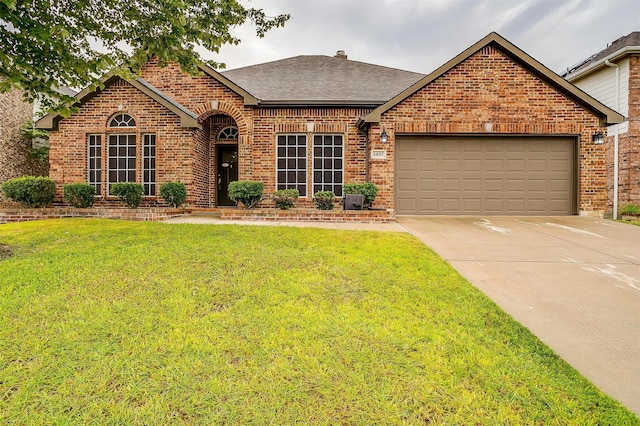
left=395, top=136, right=576, bottom=215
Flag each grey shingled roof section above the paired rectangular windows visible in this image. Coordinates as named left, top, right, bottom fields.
left=221, top=52, right=424, bottom=106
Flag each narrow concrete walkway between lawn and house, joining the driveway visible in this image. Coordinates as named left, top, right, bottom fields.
left=163, top=216, right=407, bottom=232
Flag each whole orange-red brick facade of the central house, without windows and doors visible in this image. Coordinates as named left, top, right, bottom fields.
left=51, top=47, right=607, bottom=213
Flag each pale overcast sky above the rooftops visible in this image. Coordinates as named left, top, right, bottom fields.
left=205, top=0, right=640, bottom=74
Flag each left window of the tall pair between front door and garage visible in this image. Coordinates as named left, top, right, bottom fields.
left=276, top=134, right=307, bottom=197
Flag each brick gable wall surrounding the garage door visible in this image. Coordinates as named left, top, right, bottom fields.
left=371, top=47, right=607, bottom=212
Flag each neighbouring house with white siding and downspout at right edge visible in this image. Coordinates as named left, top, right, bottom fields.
left=564, top=31, right=640, bottom=213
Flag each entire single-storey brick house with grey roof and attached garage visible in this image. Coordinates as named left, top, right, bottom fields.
left=38, top=33, right=623, bottom=215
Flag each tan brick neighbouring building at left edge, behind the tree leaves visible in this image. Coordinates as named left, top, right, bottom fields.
left=0, top=89, right=49, bottom=199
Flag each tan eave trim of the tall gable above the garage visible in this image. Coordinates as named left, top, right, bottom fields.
left=360, top=32, right=624, bottom=125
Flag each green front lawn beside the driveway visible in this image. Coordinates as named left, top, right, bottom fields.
left=0, top=219, right=639, bottom=425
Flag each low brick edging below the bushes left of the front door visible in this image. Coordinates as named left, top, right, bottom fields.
left=0, top=207, right=189, bottom=224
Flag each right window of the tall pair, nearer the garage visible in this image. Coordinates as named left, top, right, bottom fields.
left=313, top=134, right=344, bottom=197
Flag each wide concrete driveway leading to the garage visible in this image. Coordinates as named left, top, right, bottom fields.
left=398, top=216, right=640, bottom=415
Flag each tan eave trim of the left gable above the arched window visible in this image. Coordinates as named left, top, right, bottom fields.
left=35, top=74, right=201, bottom=130
